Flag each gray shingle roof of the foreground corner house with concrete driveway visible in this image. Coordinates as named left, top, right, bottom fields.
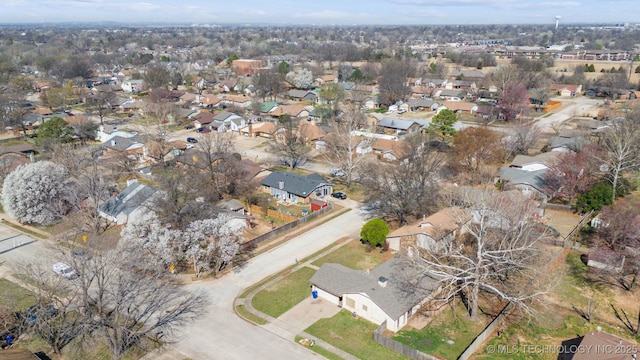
left=311, top=258, right=437, bottom=319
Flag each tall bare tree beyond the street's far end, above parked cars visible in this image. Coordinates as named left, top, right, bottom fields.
left=324, top=106, right=373, bottom=186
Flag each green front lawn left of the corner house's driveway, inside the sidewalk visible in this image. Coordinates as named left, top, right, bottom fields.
left=251, top=267, right=316, bottom=318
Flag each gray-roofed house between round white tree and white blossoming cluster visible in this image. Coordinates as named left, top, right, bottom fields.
left=98, top=180, right=158, bottom=225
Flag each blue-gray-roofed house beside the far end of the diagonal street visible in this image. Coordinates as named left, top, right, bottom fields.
left=261, top=171, right=333, bottom=203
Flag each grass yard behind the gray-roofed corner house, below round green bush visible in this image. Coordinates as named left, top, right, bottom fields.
left=313, top=240, right=393, bottom=270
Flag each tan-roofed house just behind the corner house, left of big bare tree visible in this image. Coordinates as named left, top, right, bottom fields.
left=387, top=207, right=471, bottom=253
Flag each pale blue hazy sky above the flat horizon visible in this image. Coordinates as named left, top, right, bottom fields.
left=0, top=0, right=640, bottom=25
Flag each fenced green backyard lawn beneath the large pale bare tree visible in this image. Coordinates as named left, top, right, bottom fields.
left=393, top=302, right=491, bottom=359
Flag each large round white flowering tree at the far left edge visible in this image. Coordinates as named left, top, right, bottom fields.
left=2, top=161, right=72, bottom=226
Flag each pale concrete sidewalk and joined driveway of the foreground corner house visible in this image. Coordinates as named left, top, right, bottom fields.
left=234, top=241, right=358, bottom=360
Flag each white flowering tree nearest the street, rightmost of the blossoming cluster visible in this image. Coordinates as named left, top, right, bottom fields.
left=184, top=215, right=244, bottom=276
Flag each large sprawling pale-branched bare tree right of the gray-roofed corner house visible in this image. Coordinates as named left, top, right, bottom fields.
left=406, top=192, right=546, bottom=318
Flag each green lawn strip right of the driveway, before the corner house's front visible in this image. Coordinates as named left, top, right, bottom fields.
left=305, top=310, right=406, bottom=360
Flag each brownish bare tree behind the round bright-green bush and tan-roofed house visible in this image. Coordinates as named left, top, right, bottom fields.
left=361, top=136, right=443, bottom=224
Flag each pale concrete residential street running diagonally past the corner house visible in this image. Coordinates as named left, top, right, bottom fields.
left=150, top=204, right=364, bottom=360
